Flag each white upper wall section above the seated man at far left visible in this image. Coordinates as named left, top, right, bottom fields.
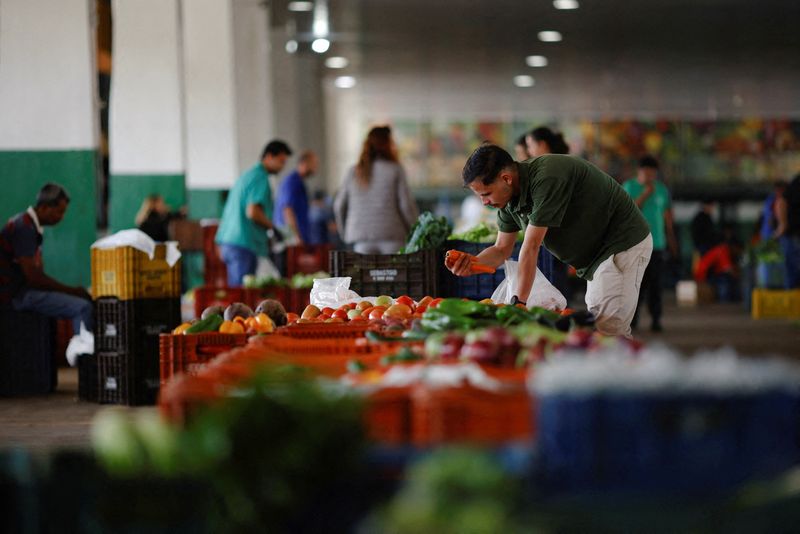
left=0, top=0, right=97, bottom=150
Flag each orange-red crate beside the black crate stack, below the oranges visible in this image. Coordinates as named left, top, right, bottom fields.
left=158, top=332, right=248, bottom=384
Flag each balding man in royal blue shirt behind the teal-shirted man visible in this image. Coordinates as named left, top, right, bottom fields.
left=275, top=150, right=318, bottom=245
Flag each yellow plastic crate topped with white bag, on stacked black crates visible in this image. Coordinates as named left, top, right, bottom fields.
left=92, top=244, right=181, bottom=300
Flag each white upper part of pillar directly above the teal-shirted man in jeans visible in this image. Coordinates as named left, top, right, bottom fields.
left=182, top=0, right=239, bottom=189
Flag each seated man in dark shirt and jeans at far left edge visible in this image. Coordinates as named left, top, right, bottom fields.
left=0, top=183, right=94, bottom=334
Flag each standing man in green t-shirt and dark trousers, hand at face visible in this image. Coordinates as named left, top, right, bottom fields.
left=622, top=156, right=678, bottom=332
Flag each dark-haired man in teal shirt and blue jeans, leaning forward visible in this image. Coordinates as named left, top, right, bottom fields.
left=215, top=140, right=292, bottom=287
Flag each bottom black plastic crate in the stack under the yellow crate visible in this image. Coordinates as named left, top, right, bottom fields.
left=97, top=351, right=161, bottom=406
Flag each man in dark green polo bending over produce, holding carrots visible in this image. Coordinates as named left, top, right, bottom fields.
left=449, top=144, right=653, bottom=336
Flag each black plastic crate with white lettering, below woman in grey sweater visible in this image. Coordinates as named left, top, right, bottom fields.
left=330, top=250, right=443, bottom=299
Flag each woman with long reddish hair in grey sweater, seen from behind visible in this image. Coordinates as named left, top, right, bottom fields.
left=334, top=126, right=417, bottom=254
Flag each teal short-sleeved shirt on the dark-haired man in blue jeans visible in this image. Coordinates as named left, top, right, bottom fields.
left=214, top=163, right=273, bottom=256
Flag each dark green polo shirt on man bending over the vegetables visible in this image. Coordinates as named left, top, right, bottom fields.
left=497, top=154, right=650, bottom=280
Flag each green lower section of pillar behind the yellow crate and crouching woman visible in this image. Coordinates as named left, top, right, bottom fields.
left=108, top=174, right=186, bottom=233
